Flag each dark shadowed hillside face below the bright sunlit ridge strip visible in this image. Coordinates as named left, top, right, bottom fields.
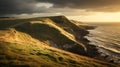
left=15, top=23, right=86, bottom=55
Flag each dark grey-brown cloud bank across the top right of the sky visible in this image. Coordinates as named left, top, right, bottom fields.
left=36, top=0, right=120, bottom=11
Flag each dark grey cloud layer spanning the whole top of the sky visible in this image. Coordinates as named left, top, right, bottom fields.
left=0, top=0, right=120, bottom=15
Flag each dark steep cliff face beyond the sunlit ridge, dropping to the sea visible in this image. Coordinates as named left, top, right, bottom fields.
left=44, top=16, right=99, bottom=58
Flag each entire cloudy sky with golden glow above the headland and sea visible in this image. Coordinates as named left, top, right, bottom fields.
left=0, top=0, right=120, bottom=22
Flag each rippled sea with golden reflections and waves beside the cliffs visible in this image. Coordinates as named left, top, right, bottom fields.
left=86, top=23, right=120, bottom=63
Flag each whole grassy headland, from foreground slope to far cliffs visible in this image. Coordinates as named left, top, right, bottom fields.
left=0, top=16, right=119, bottom=67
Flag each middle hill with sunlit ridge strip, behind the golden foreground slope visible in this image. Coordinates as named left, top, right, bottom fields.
left=0, top=15, right=87, bottom=55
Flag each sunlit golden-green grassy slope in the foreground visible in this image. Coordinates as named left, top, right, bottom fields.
left=0, top=29, right=117, bottom=67
